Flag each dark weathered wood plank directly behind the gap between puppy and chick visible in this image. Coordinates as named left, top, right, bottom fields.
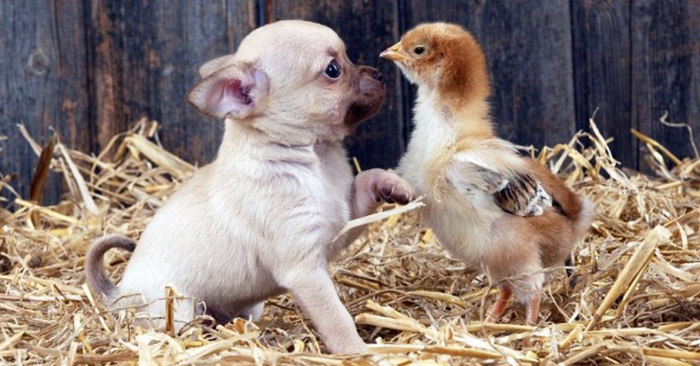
left=267, top=0, right=406, bottom=168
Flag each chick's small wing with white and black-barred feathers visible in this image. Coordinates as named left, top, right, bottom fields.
left=446, top=144, right=552, bottom=216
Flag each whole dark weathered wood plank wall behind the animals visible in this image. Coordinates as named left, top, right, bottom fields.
left=0, top=0, right=700, bottom=204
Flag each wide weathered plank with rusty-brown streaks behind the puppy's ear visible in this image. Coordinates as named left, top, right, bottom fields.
left=86, top=0, right=257, bottom=165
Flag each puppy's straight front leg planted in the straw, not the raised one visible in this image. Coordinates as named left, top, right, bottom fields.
left=283, top=267, right=367, bottom=353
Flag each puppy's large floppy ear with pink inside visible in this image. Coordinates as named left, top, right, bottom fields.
left=187, top=64, right=269, bottom=119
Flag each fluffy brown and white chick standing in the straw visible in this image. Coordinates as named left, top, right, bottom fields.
left=380, top=23, right=593, bottom=324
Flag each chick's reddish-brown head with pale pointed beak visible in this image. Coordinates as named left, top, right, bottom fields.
left=380, top=23, right=489, bottom=99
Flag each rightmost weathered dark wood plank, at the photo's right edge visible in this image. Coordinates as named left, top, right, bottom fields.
left=631, top=0, right=700, bottom=166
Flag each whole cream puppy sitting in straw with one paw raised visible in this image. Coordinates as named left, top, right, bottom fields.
left=85, top=21, right=414, bottom=353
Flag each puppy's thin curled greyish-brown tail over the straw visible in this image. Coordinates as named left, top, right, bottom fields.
left=85, top=235, right=136, bottom=299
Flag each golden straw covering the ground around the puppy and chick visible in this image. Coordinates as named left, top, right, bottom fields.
left=0, top=121, right=700, bottom=365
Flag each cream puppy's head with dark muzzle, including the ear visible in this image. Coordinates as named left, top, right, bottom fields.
left=188, top=21, right=385, bottom=143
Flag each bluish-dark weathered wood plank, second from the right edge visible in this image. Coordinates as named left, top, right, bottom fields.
left=571, top=0, right=639, bottom=168
